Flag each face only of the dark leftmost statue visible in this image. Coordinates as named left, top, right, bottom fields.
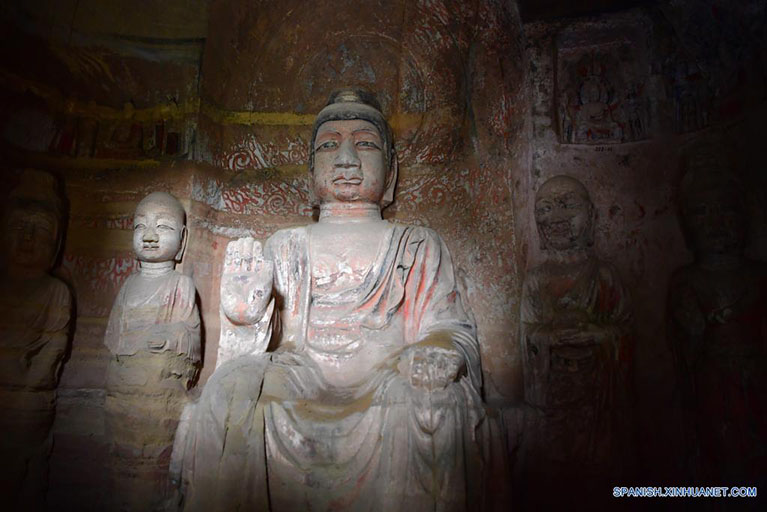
left=5, top=208, right=58, bottom=273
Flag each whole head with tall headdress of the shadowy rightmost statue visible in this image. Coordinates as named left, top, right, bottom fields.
left=680, top=145, right=748, bottom=256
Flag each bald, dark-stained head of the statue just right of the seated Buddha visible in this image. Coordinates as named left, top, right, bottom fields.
left=535, top=175, right=596, bottom=251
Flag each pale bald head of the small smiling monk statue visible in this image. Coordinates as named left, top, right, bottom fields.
left=133, top=192, right=186, bottom=263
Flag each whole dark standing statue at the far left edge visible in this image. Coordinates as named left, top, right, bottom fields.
left=0, top=170, right=72, bottom=510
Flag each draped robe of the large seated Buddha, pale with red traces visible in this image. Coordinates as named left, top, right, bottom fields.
left=174, top=224, right=485, bottom=511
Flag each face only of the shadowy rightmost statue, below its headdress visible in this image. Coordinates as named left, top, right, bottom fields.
left=683, top=186, right=747, bottom=254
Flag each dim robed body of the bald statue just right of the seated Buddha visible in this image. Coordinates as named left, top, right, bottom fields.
left=521, top=256, right=632, bottom=492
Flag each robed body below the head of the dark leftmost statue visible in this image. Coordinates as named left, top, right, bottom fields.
left=0, top=276, right=72, bottom=510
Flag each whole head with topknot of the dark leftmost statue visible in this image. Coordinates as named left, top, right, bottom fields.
left=3, top=169, right=64, bottom=279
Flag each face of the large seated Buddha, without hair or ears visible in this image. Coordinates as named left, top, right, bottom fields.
left=314, top=119, right=388, bottom=204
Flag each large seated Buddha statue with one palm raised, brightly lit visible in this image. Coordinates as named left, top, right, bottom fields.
left=174, top=89, right=484, bottom=511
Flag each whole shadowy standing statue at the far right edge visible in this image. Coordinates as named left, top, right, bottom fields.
left=669, top=148, right=767, bottom=485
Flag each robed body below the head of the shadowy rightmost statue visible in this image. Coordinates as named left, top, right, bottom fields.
left=669, top=261, right=767, bottom=485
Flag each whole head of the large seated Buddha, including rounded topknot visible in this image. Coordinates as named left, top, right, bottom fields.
left=309, top=88, right=397, bottom=208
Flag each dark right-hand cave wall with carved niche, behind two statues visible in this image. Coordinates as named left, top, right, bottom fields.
left=516, top=1, right=767, bottom=479
